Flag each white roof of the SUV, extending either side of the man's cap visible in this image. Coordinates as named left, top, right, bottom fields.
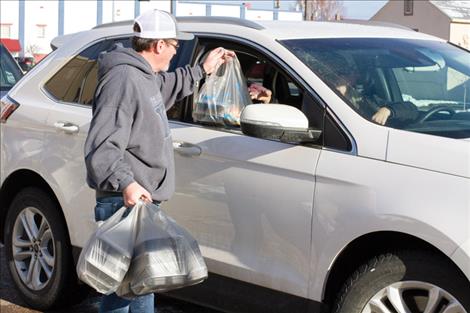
left=51, top=16, right=445, bottom=49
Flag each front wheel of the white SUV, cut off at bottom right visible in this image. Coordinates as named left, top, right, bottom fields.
left=332, top=251, right=470, bottom=313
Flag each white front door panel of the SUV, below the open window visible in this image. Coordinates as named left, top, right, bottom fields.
left=164, top=38, right=321, bottom=297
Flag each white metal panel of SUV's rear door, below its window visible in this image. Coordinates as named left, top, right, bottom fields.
left=42, top=102, right=96, bottom=247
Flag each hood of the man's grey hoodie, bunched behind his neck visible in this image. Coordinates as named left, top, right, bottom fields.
left=98, top=44, right=155, bottom=80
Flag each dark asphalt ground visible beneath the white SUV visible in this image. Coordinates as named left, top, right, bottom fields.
left=0, top=244, right=220, bottom=313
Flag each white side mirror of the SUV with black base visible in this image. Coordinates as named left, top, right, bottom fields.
left=240, top=104, right=322, bottom=143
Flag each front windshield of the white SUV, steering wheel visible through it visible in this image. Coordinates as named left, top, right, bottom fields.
left=282, top=38, right=470, bottom=138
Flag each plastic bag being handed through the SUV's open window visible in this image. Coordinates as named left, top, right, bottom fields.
left=193, top=56, right=252, bottom=126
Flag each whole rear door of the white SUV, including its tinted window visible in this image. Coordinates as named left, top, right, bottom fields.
left=43, top=38, right=130, bottom=247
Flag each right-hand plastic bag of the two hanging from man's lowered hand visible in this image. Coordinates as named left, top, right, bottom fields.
left=116, top=203, right=207, bottom=298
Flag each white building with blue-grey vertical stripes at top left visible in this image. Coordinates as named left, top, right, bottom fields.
left=0, top=0, right=171, bottom=61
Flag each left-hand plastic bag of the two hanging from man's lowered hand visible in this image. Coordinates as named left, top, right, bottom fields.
left=77, top=207, right=138, bottom=294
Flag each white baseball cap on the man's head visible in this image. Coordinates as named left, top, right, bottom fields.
left=134, top=9, right=194, bottom=40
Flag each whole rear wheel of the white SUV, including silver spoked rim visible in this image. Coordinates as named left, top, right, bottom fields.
left=5, top=188, right=76, bottom=310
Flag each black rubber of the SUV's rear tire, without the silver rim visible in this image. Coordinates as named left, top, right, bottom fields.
left=5, top=187, right=76, bottom=310
